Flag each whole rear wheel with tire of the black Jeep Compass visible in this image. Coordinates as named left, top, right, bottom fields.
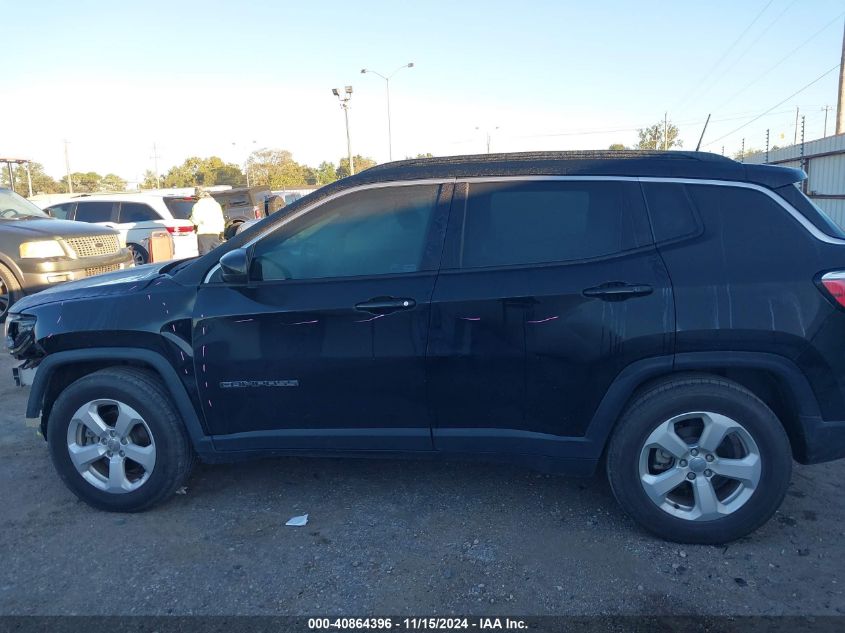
left=607, top=376, right=792, bottom=544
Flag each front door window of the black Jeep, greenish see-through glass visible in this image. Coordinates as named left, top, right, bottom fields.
left=253, top=185, right=439, bottom=280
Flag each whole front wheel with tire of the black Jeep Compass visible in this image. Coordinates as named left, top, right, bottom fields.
left=47, top=367, right=195, bottom=512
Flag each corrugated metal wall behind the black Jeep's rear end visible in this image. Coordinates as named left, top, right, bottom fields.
left=745, top=134, right=845, bottom=228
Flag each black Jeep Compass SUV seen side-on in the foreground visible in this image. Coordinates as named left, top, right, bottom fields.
left=7, top=152, right=845, bottom=543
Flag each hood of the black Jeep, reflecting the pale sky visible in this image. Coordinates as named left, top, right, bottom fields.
left=11, top=261, right=173, bottom=313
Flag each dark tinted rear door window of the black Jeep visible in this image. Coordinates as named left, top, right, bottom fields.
left=457, top=181, right=650, bottom=268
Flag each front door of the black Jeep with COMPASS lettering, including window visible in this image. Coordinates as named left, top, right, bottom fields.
left=194, top=184, right=452, bottom=450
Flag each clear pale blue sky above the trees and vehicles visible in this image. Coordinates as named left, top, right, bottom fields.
left=0, top=0, right=845, bottom=183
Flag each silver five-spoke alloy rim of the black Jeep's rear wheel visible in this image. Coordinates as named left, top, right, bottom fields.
left=639, top=411, right=761, bottom=521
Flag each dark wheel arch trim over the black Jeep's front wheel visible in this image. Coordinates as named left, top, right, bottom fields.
left=26, top=347, right=212, bottom=455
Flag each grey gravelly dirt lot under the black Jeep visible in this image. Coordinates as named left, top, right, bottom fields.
left=0, top=354, right=845, bottom=615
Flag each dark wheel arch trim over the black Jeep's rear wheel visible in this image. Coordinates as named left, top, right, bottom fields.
left=587, top=351, right=821, bottom=463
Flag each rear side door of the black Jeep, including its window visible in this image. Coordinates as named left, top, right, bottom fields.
left=428, top=179, right=674, bottom=456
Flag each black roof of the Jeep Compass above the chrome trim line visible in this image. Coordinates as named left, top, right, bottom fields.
left=337, top=150, right=806, bottom=188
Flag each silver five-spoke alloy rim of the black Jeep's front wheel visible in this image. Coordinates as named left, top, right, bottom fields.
left=67, top=398, right=156, bottom=494
